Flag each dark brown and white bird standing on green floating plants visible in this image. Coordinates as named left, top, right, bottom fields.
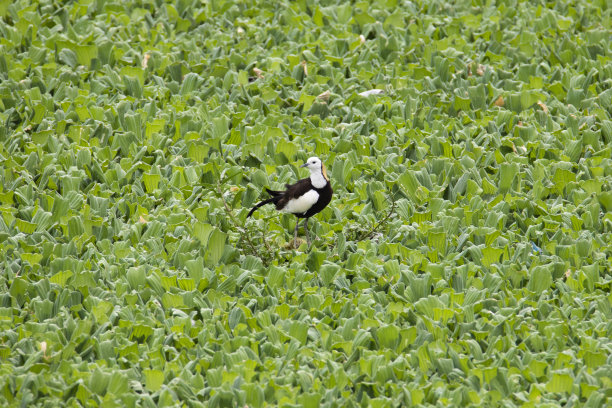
left=247, top=157, right=334, bottom=245
